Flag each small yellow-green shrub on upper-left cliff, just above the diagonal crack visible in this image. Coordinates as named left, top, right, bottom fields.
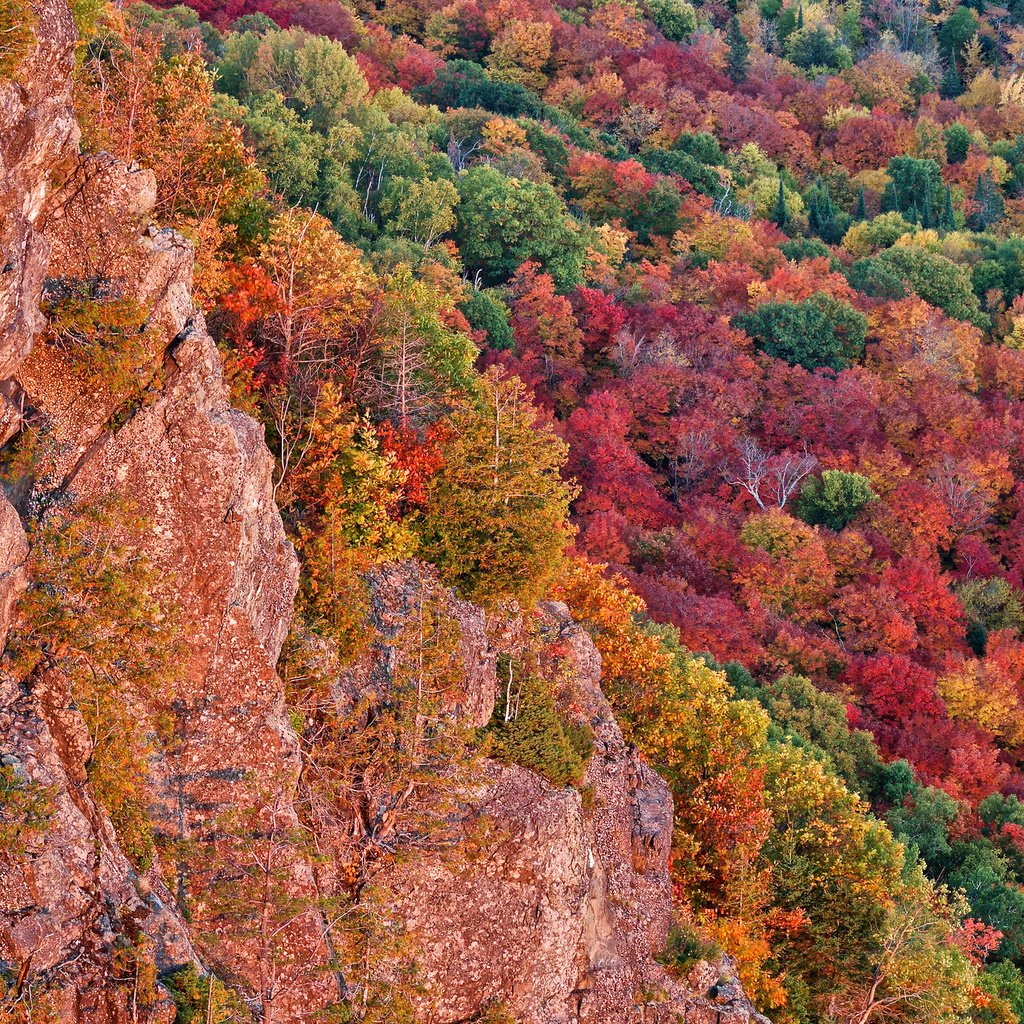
left=43, top=285, right=148, bottom=395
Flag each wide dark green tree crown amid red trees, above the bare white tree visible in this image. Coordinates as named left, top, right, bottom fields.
left=734, top=292, right=867, bottom=370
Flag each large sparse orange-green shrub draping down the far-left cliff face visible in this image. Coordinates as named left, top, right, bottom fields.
left=5, top=500, right=178, bottom=868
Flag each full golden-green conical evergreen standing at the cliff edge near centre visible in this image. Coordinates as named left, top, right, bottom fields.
left=420, top=374, right=573, bottom=607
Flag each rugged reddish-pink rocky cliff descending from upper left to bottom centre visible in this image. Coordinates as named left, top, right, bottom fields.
left=0, top=0, right=770, bottom=1024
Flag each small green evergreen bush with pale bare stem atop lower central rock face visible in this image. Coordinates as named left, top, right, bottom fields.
left=487, top=660, right=592, bottom=786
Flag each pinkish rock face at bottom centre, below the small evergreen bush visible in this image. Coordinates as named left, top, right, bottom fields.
left=380, top=604, right=761, bottom=1024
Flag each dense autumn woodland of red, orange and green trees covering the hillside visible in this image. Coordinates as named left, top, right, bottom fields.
left=14, top=0, right=1024, bottom=1011
